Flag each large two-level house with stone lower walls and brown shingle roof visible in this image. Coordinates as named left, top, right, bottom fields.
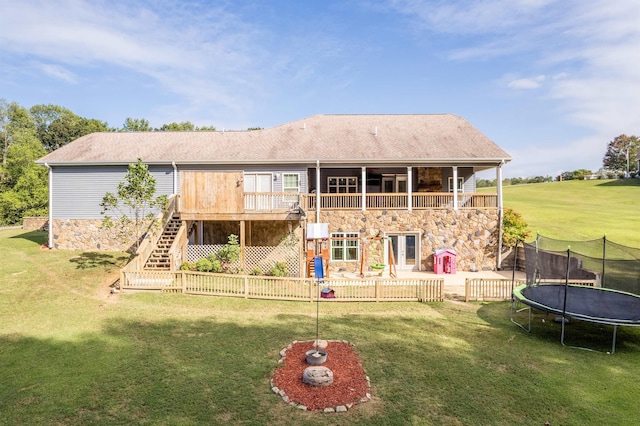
left=38, top=114, right=510, bottom=275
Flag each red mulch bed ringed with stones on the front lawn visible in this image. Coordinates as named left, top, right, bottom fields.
left=273, top=342, right=369, bottom=410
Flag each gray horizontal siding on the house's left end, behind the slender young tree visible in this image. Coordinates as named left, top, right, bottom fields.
left=51, top=166, right=173, bottom=219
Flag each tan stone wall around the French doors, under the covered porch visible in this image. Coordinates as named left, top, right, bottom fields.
left=318, top=209, right=499, bottom=271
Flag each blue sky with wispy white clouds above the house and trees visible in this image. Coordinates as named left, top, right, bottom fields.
left=0, top=0, right=640, bottom=178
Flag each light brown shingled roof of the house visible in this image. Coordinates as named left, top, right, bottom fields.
left=37, top=114, right=511, bottom=167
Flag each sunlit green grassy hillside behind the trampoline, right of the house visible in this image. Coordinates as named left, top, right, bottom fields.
left=483, top=179, right=640, bottom=247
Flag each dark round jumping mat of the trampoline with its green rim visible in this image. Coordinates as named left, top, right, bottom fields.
left=513, top=284, right=640, bottom=326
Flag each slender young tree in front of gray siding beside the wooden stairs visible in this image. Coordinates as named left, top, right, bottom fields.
left=100, top=158, right=167, bottom=251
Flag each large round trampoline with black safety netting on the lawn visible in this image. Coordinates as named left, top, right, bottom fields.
left=511, top=236, right=640, bottom=354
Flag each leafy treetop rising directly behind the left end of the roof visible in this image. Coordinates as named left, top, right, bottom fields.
left=30, top=105, right=111, bottom=151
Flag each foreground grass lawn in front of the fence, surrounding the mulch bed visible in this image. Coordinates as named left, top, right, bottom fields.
left=0, top=229, right=640, bottom=425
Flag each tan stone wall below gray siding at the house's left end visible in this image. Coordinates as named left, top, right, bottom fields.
left=52, top=219, right=134, bottom=251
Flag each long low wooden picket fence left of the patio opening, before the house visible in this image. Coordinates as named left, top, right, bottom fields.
left=120, top=270, right=444, bottom=302
